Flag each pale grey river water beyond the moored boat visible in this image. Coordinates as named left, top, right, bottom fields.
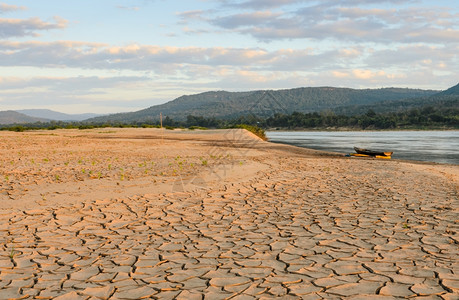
left=266, top=131, right=459, bottom=165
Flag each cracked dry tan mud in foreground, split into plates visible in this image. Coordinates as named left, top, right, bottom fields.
left=0, top=127, right=459, bottom=299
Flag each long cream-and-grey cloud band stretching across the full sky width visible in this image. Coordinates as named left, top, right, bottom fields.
left=0, top=41, right=459, bottom=78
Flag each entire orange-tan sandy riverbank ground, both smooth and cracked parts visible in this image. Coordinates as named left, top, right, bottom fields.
left=0, top=128, right=459, bottom=299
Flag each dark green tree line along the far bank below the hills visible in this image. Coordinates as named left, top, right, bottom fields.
left=0, top=106, right=459, bottom=131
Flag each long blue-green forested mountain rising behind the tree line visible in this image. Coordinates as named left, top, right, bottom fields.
left=86, top=87, right=439, bottom=123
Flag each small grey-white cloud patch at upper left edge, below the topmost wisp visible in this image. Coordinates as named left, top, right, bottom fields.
left=0, top=17, right=68, bottom=38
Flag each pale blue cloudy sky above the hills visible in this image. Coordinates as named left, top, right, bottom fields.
left=0, top=0, right=459, bottom=114
